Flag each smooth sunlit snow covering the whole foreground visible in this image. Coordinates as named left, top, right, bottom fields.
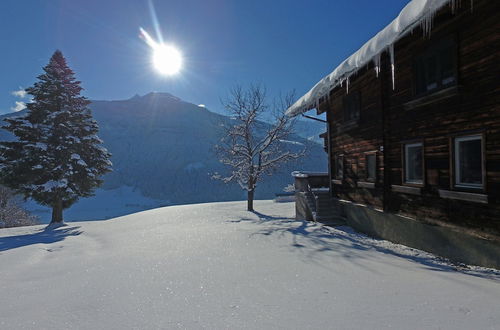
left=0, top=201, right=500, bottom=329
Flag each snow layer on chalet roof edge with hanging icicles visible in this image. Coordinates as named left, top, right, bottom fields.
left=286, top=0, right=460, bottom=116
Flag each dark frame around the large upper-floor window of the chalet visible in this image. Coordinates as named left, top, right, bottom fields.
left=413, top=35, right=459, bottom=97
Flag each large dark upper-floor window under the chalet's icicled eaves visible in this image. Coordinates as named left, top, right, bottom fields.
left=415, top=38, right=456, bottom=95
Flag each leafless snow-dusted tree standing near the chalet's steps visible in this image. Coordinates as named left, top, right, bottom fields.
left=213, top=85, right=305, bottom=211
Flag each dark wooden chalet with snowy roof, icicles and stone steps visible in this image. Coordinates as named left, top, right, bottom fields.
left=288, top=0, right=500, bottom=268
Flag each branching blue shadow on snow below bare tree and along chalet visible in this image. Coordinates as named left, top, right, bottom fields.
left=231, top=211, right=500, bottom=281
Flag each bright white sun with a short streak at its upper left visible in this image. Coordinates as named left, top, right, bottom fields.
left=140, top=28, right=182, bottom=76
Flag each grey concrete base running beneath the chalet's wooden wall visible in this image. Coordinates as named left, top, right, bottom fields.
left=335, top=200, right=500, bottom=269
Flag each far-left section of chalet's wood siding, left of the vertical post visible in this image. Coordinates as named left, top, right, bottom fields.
left=327, top=61, right=383, bottom=208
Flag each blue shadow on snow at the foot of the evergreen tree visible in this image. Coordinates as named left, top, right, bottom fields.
left=0, top=225, right=82, bottom=252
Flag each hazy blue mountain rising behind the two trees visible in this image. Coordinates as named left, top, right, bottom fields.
left=0, top=92, right=327, bottom=219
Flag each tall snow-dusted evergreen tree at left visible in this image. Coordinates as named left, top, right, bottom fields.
left=0, top=50, right=112, bottom=223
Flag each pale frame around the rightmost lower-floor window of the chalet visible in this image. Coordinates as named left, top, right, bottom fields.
left=451, top=133, right=486, bottom=191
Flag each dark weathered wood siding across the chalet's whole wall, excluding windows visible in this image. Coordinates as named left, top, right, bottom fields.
left=323, top=0, right=500, bottom=236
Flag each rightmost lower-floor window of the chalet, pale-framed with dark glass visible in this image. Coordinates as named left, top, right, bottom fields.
left=454, top=135, right=483, bottom=188
